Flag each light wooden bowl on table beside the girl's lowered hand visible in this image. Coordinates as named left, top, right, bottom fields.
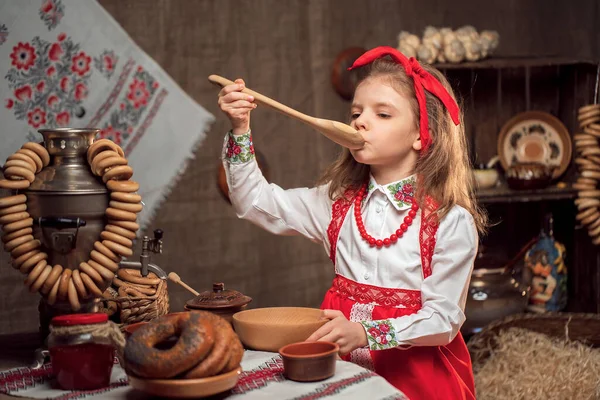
left=233, top=307, right=327, bottom=353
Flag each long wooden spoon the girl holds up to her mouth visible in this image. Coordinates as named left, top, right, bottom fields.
left=208, top=75, right=365, bottom=150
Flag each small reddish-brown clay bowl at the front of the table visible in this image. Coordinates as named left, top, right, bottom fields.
left=279, top=342, right=340, bottom=382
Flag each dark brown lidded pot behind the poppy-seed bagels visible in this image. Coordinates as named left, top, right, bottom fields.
left=184, top=282, right=252, bottom=324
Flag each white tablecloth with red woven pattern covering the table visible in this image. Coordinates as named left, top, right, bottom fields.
left=0, top=350, right=406, bottom=400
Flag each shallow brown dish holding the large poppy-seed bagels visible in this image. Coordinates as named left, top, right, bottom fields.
left=128, top=368, right=242, bottom=399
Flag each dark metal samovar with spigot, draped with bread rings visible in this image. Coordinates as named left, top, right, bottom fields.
left=24, top=128, right=167, bottom=346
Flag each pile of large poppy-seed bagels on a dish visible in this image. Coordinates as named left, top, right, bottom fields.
left=124, top=311, right=244, bottom=379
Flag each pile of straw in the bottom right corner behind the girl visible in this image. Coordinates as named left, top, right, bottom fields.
left=473, top=328, right=600, bottom=400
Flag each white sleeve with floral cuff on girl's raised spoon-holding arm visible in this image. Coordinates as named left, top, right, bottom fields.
left=222, top=131, right=332, bottom=243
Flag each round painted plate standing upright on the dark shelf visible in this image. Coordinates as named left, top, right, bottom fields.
left=498, top=111, right=572, bottom=178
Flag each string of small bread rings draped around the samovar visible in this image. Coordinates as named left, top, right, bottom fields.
left=0, top=139, right=142, bottom=311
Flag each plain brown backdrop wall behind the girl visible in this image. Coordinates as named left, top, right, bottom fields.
left=0, top=0, right=600, bottom=333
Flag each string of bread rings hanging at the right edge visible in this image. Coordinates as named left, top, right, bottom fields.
left=573, top=104, right=600, bottom=245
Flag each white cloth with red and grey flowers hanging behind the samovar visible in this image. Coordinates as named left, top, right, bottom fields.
left=0, top=0, right=214, bottom=226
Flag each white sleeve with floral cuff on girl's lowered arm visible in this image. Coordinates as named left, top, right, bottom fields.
left=361, top=206, right=478, bottom=350
